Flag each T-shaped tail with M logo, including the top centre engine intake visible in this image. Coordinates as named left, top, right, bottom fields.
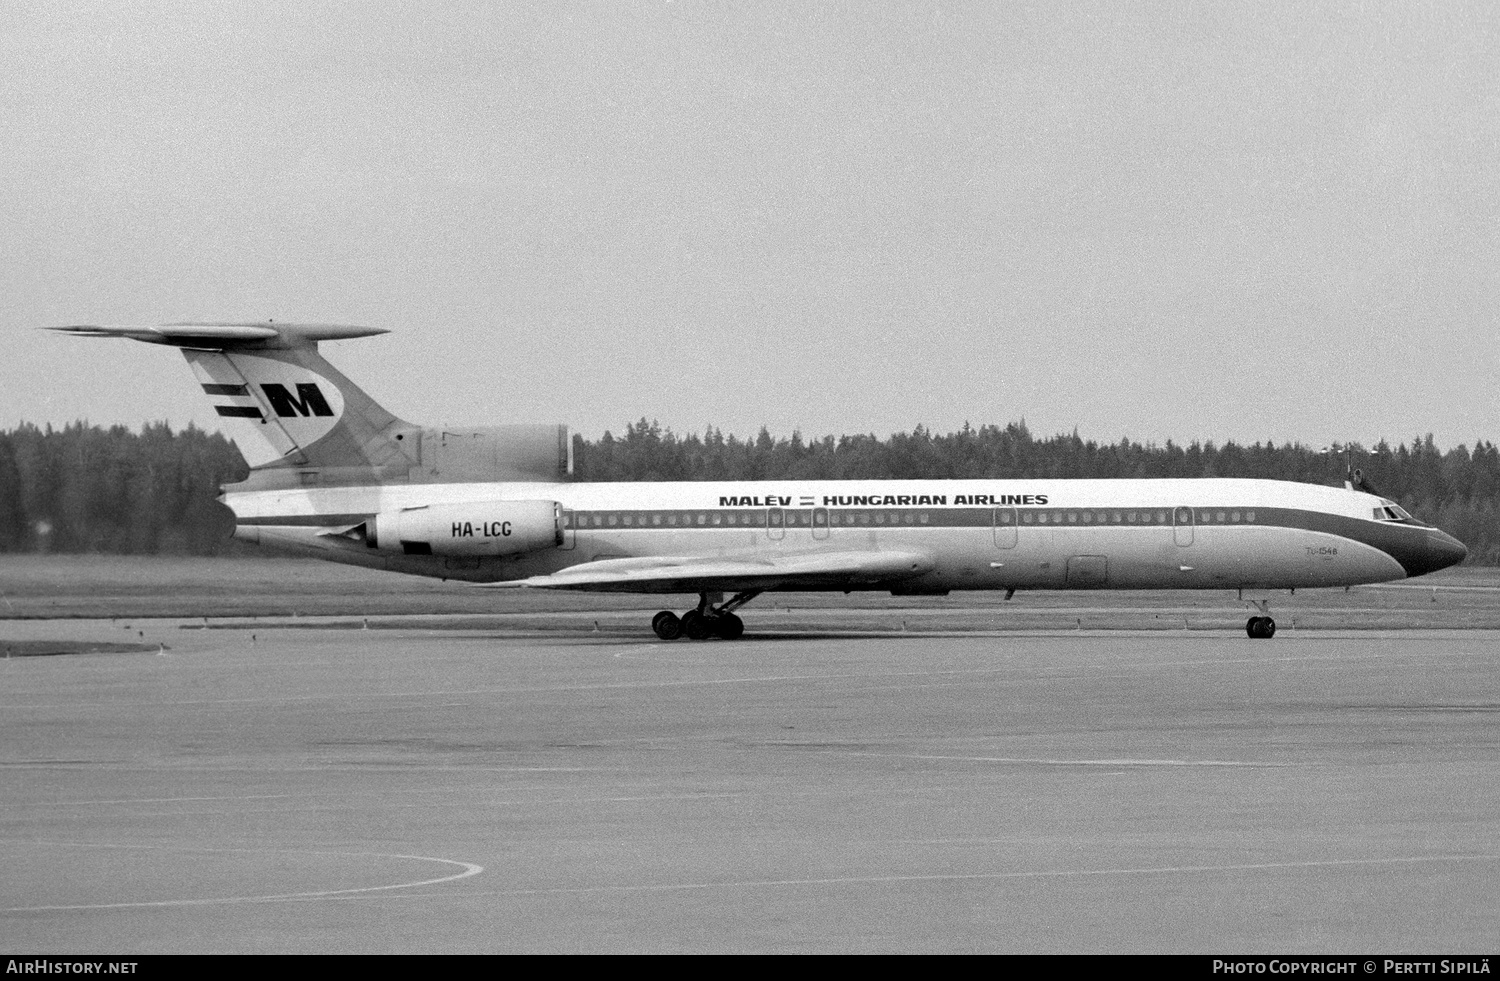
left=51, top=323, right=570, bottom=488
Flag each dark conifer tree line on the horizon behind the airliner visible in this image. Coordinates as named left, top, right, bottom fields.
left=0, top=419, right=1500, bottom=566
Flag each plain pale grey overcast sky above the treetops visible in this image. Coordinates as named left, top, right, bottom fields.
left=0, top=0, right=1500, bottom=447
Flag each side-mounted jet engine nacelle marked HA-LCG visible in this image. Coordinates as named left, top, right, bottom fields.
left=365, top=501, right=563, bottom=557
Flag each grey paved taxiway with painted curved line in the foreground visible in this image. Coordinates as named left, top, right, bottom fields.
left=0, top=621, right=1500, bottom=954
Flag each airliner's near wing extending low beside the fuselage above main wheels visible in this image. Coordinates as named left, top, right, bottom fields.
left=482, top=552, right=933, bottom=593
